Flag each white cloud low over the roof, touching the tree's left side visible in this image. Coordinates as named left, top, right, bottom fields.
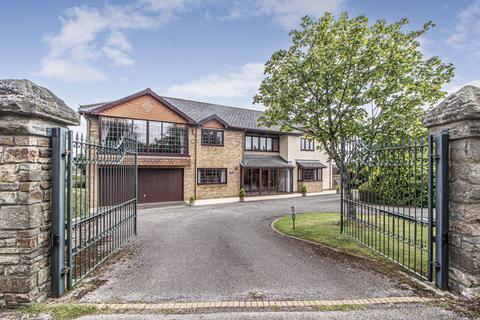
left=163, top=63, right=264, bottom=99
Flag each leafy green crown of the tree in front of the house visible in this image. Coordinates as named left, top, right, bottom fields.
left=254, top=13, right=454, bottom=164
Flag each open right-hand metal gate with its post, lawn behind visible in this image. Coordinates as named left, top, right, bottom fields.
left=340, top=132, right=448, bottom=289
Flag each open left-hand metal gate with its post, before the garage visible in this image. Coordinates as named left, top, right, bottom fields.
left=51, top=128, right=137, bottom=297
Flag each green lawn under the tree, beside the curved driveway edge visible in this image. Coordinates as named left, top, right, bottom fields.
left=274, top=213, right=428, bottom=275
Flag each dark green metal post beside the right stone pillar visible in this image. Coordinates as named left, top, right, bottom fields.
left=435, top=130, right=449, bottom=290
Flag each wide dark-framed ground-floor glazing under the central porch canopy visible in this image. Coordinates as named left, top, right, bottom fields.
left=242, top=168, right=293, bottom=195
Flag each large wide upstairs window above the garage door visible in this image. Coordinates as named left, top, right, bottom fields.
left=100, top=117, right=188, bottom=154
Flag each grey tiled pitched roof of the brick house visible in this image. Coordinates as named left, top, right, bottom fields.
left=79, top=89, right=292, bottom=133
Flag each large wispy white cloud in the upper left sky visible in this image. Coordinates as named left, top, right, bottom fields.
left=37, top=0, right=187, bottom=82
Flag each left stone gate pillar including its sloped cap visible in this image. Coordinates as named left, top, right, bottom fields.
left=0, top=80, right=79, bottom=306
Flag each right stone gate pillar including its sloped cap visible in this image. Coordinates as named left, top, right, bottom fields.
left=424, top=86, right=480, bottom=299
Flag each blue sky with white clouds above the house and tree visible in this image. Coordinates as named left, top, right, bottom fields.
left=0, top=0, right=480, bottom=121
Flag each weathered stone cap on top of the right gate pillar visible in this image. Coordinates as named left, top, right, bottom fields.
left=423, top=85, right=480, bottom=128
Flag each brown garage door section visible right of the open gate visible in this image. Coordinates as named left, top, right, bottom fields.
left=138, top=168, right=183, bottom=203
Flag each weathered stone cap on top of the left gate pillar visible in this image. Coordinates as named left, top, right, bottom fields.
left=0, top=79, right=80, bottom=125
